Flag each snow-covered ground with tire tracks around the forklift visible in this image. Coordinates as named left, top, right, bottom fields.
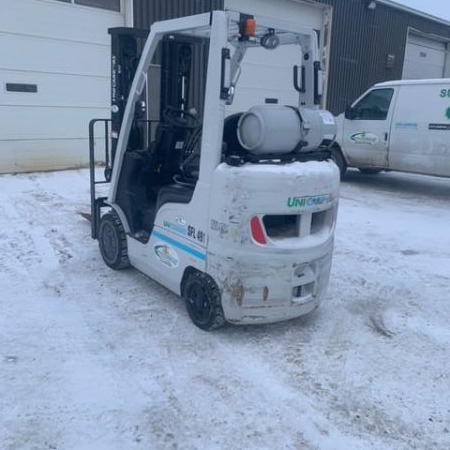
left=0, top=170, right=450, bottom=450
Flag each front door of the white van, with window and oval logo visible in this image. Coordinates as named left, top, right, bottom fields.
left=343, top=88, right=394, bottom=168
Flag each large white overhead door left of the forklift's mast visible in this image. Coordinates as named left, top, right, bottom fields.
left=0, top=0, right=124, bottom=173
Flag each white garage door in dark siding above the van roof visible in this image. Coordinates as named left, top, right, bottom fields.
left=403, top=33, right=447, bottom=79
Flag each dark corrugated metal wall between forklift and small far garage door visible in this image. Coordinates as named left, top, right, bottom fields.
left=315, top=0, right=450, bottom=114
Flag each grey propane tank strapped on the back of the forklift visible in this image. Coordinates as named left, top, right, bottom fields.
left=237, top=105, right=337, bottom=155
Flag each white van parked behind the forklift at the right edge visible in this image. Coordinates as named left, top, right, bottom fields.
left=332, top=78, right=450, bottom=177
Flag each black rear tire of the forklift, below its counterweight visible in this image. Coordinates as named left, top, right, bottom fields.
left=183, top=271, right=225, bottom=331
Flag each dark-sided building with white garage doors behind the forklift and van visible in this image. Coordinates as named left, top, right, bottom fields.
left=0, top=0, right=450, bottom=173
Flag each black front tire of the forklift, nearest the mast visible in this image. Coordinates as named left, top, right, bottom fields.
left=98, top=211, right=130, bottom=270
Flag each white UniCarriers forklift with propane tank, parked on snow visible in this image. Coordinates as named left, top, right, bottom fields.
left=90, top=11, right=339, bottom=330
